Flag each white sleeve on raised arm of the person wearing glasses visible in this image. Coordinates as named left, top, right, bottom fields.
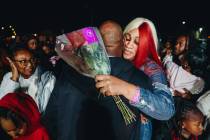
left=0, top=72, right=20, bottom=99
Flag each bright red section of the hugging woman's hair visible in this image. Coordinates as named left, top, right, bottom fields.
left=133, top=22, right=162, bottom=68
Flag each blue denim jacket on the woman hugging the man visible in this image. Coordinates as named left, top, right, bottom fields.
left=130, top=59, right=175, bottom=120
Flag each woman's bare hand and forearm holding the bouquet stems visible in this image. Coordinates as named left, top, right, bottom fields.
left=95, top=75, right=137, bottom=100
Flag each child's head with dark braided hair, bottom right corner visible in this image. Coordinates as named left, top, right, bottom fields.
left=171, top=100, right=204, bottom=140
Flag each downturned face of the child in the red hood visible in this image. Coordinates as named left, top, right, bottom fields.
left=0, top=118, right=27, bottom=139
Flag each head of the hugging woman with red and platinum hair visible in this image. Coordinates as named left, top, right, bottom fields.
left=123, top=18, right=162, bottom=68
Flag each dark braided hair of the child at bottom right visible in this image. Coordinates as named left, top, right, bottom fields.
left=173, top=98, right=202, bottom=137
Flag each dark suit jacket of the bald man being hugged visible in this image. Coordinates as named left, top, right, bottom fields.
left=43, top=57, right=151, bottom=140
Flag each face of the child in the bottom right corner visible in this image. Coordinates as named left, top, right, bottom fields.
left=182, top=112, right=204, bottom=136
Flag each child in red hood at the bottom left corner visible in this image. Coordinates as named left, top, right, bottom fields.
left=0, top=93, right=49, bottom=140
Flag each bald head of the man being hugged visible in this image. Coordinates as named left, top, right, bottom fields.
left=99, top=20, right=123, bottom=57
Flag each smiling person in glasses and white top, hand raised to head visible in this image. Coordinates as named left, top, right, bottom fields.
left=0, top=47, right=56, bottom=113
